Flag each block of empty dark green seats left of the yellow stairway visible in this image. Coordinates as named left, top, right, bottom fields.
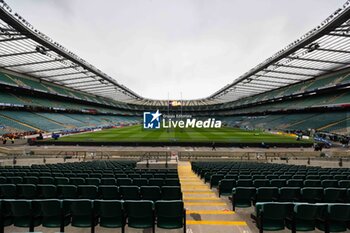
left=0, top=161, right=186, bottom=232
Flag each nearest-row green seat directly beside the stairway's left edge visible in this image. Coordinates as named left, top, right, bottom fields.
left=155, top=201, right=186, bottom=233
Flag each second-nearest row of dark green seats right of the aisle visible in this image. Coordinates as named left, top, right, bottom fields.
left=232, top=187, right=350, bottom=209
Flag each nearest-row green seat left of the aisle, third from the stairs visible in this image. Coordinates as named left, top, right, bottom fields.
left=94, top=200, right=125, bottom=230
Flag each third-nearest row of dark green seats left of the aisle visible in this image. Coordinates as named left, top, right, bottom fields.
left=0, top=176, right=180, bottom=186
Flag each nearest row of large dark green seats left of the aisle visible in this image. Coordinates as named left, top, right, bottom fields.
left=0, top=199, right=186, bottom=232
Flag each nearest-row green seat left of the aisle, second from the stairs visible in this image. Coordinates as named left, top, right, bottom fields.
left=124, top=201, right=155, bottom=233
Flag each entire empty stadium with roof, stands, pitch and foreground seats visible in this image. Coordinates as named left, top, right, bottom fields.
left=0, top=0, right=350, bottom=233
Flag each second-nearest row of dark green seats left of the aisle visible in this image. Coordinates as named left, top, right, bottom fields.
left=0, top=184, right=182, bottom=201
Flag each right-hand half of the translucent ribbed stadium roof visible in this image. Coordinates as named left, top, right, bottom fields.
left=209, top=1, right=350, bottom=102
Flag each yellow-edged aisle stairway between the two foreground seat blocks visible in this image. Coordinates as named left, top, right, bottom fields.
left=178, top=162, right=250, bottom=233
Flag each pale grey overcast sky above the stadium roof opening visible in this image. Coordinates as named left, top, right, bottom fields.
left=6, top=0, right=345, bottom=99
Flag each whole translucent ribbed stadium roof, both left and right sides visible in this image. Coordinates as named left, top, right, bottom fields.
left=0, top=0, right=350, bottom=106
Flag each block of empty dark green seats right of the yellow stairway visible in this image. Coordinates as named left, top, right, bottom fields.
left=192, top=162, right=350, bottom=232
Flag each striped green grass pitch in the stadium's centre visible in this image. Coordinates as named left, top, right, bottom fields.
left=58, top=125, right=312, bottom=143
